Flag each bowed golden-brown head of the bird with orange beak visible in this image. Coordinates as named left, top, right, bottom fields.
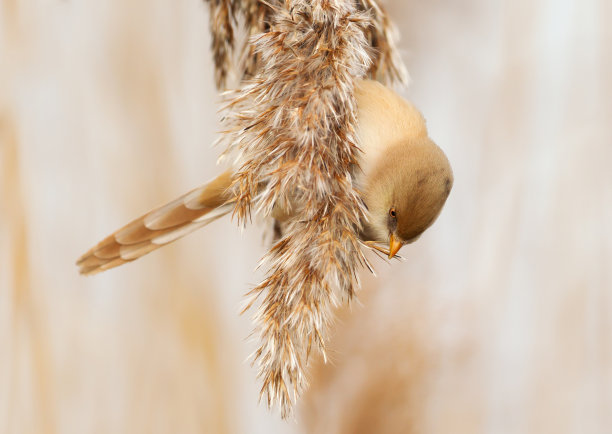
left=365, top=136, right=453, bottom=259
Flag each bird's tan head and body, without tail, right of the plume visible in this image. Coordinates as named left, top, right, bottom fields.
left=355, top=80, right=453, bottom=258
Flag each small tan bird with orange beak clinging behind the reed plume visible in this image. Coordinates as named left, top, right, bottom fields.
left=76, top=80, right=454, bottom=275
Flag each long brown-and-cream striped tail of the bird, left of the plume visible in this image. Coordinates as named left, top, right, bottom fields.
left=76, top=170, right=234, bottom=274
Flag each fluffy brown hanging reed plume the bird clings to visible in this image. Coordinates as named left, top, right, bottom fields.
left=211, top=0, right=404, bottom=417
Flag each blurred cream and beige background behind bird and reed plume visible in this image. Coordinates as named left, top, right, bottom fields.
left=0, top=0, right=612, bottom=434
